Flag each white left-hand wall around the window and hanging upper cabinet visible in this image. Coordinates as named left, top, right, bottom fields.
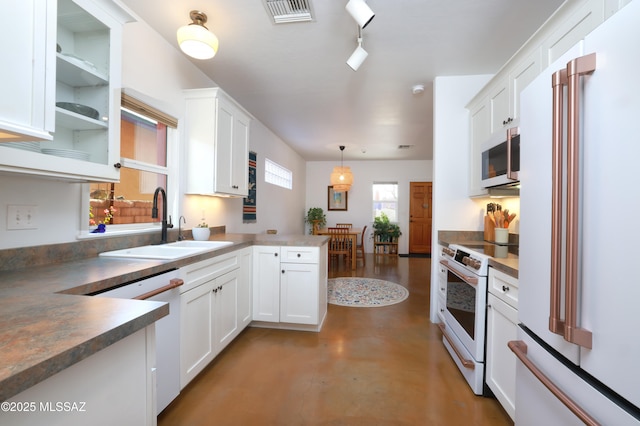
left=123, top=19, right=305, bottom=234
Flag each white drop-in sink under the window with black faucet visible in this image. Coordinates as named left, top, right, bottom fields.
left=100, top=241, right=233, bottom=260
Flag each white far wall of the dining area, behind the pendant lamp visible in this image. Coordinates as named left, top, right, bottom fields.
left=302, top=159, right=433, bottom=254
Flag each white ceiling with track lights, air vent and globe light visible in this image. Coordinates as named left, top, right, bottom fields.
left=121, top=0, right=562, bottom=161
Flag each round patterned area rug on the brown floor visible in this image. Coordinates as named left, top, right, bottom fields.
left=328, top=278, right=409, bottom=308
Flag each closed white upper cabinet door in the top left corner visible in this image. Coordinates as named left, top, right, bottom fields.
left=0, top=0, right=57, bottom=142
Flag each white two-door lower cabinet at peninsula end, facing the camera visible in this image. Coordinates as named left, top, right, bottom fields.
left=253, top=245, right=327, bottom=331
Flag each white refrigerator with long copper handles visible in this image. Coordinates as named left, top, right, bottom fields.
left=510, top=0, right=640, bottom=426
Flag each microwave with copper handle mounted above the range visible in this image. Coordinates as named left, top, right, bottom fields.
left=481, top=127, right=520, bottom=188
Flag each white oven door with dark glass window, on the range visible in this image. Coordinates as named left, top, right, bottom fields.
left=443, top=262, right=487, bottom=362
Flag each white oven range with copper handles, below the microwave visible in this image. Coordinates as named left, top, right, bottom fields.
left=439, top=244, right=495, bottom=395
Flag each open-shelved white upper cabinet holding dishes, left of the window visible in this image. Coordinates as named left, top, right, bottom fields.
left=0, top=0, right=133, bottom=182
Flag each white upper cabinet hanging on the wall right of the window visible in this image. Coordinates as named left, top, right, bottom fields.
left=185, top=88, right=251, bottom=197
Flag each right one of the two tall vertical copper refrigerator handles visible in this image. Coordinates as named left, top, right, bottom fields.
left=564, top=53, right=596, bottom=349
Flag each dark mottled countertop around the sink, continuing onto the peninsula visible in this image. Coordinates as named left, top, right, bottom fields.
left=0, top=234, right=328, bottom=401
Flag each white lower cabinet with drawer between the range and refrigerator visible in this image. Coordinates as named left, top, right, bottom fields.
left=486, top=268, right=518, bottom=419
